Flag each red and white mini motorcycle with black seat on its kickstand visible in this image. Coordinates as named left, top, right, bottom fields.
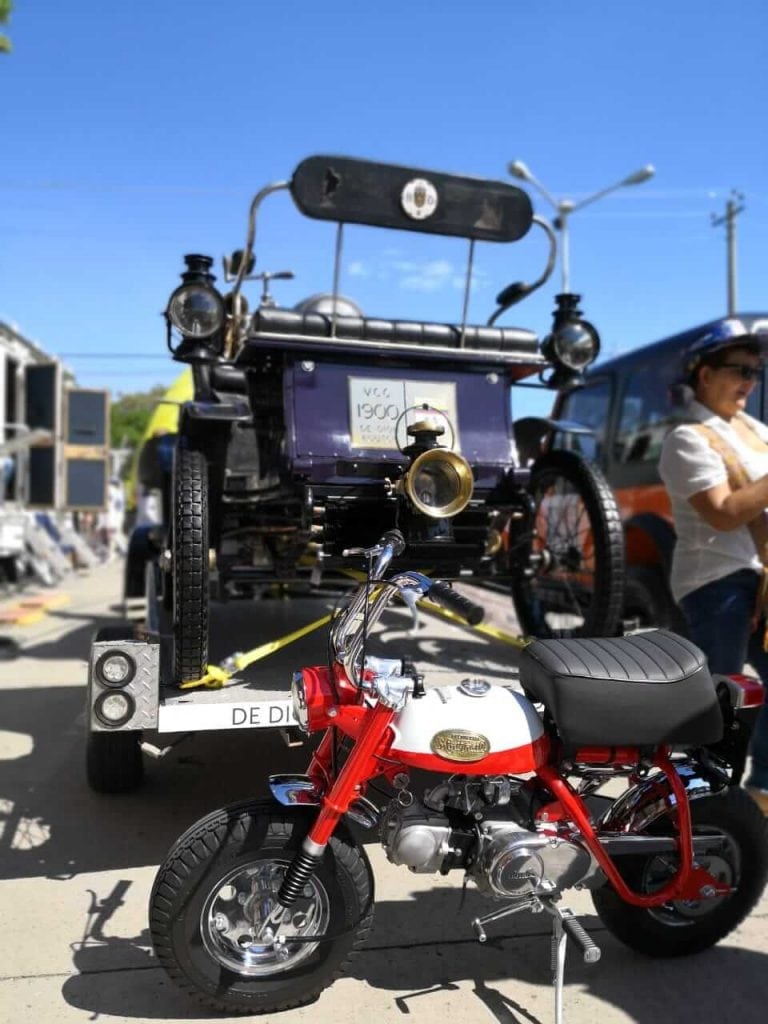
left=150, top=530, right=768, bottom=1024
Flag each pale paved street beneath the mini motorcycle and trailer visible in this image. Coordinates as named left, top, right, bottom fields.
left=0, top=563, right=768, bottom=1024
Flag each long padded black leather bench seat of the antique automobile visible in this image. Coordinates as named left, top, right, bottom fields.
left=246, top=307, right=539, bottom=355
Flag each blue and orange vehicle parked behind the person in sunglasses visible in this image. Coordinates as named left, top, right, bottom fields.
left=548, top=313, right=768, bottom=633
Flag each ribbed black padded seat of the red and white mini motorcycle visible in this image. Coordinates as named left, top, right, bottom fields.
left=519, top=630, right=723, bottom=749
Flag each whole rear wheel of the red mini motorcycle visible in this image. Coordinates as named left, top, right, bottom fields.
left=592, top=788, right=768, bottom=956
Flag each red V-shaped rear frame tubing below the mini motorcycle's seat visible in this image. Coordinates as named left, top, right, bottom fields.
left=539, top=751, right=731, bottom=907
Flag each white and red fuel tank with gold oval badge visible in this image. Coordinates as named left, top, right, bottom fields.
left=390, top=679, right=549, bottom=775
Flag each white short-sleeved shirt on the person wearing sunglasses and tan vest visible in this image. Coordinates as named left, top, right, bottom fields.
left=658, top=401, right=768, bottom=601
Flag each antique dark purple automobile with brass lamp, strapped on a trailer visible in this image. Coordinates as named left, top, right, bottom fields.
left=158, top=156, right=624, bottom=682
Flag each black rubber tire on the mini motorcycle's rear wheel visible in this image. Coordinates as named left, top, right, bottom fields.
left=592, top=787, right=768, bottom=956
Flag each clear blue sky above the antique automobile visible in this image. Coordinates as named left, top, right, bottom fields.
left=0, top=0, right=768, bottom=419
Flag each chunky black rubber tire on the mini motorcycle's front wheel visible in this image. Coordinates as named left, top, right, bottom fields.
left=150, top=800, right=374, bottom=1014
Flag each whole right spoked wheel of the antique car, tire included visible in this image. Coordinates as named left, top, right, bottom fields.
left=510, top=452, right=625, bottom=637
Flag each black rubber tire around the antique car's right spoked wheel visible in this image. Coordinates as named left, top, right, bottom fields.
left=512, top=451, right=625, bottom=637
